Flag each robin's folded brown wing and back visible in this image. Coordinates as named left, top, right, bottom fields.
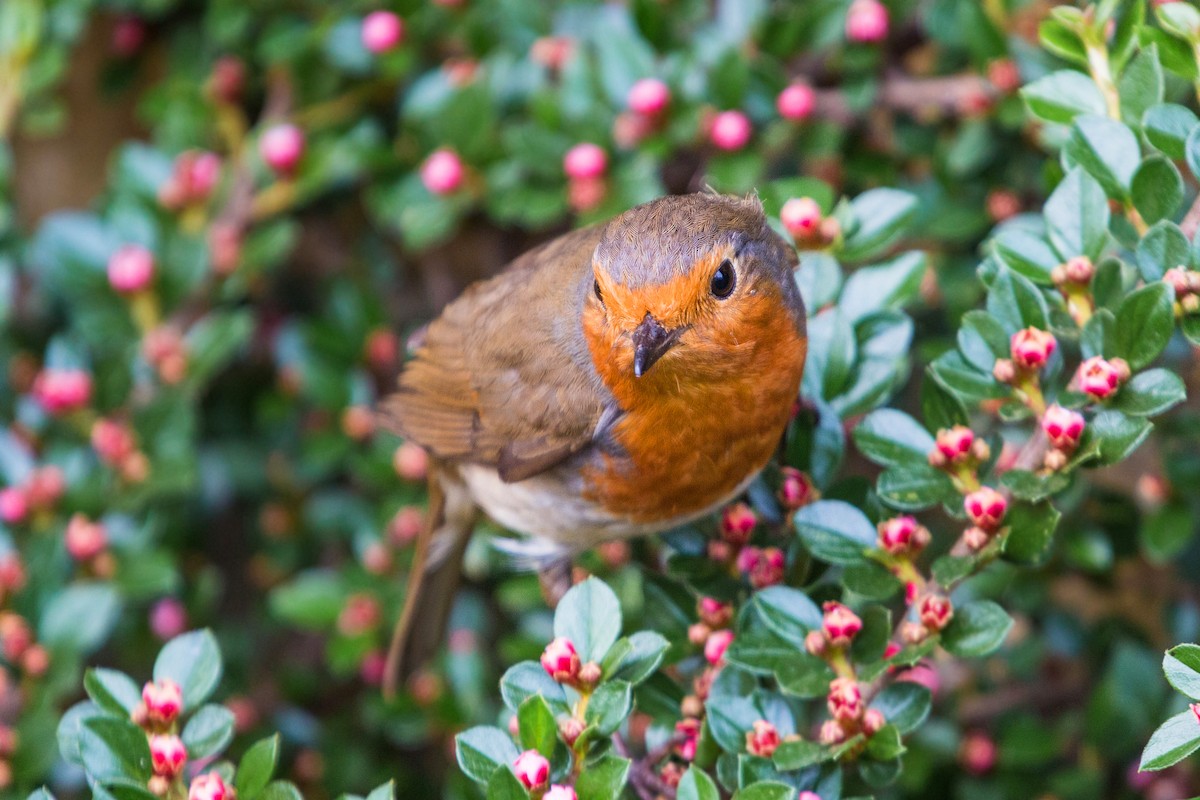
left=383, top=228, right=605, bottom=481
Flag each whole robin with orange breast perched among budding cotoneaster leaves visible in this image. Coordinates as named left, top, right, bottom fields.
left=383, top=193, right=808, bottom=692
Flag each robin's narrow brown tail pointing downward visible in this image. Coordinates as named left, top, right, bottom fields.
left=383, top=464, right=476, bottom=698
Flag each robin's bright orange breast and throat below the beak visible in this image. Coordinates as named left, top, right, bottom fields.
left=584, top=284, right=806, bottom=523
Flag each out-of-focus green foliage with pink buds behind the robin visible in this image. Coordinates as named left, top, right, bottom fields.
left=0, top=0, right=1200, bottom=800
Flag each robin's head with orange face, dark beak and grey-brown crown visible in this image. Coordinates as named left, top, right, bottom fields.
left=583, top=194, right=804, bottom=397
